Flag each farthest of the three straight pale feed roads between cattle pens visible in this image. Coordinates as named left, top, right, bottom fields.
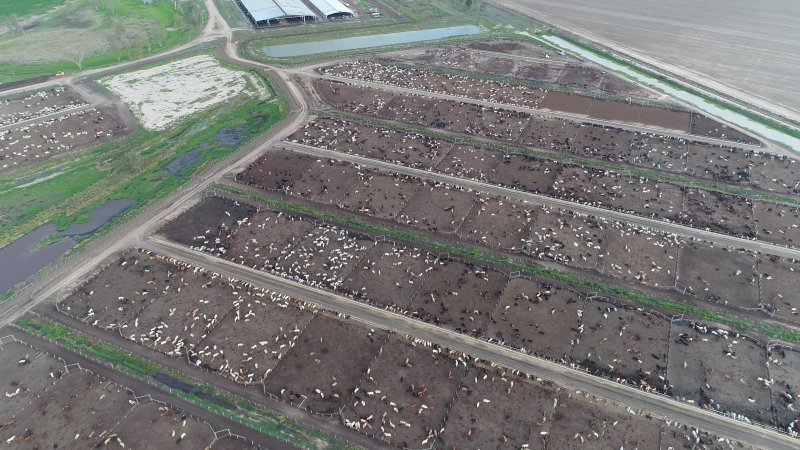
left=304, top=70, right=767, bottom=151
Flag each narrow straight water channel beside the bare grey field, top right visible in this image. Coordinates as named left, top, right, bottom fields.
left=542, top=35, right=800, bottom=152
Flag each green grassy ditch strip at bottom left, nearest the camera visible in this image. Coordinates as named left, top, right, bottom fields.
left=15, top=315, right=359, bottom=450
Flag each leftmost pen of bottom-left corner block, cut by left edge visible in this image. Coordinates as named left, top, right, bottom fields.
left=0, top=341, right=64, bottom=424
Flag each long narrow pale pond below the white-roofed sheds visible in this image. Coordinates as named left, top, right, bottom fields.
left=262, top=25, right=484, bottom=58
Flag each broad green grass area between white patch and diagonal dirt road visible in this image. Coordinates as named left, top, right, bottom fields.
left=0, top=53, right=288, bottom=253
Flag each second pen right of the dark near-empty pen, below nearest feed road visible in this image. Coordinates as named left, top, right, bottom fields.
left=437, top=367, right=558, bottom=450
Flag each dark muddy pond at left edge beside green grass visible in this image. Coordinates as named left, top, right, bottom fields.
left=0, top=199, right=133, bottom=295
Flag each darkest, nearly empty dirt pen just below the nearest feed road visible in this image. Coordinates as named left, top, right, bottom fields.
left=264, top=315, right=386, bottom=413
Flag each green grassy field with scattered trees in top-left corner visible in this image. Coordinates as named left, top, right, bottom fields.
left=0, top=0, right=208, bottom=83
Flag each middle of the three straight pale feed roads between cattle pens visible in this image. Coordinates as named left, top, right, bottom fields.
left=281, top=142, right=800, bottom=259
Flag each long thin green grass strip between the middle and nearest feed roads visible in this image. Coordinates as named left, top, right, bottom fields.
left=216, top=185, right=800, bottom=343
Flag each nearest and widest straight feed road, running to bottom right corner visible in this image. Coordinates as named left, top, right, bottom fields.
left=139, top=238, right=797, bottom=449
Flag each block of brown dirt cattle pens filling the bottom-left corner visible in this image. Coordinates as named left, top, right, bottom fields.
left=0, top=338, right=249, bottom=450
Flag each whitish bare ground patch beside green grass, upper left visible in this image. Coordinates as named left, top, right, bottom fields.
left=101, top=55, right=256, bottom=130
